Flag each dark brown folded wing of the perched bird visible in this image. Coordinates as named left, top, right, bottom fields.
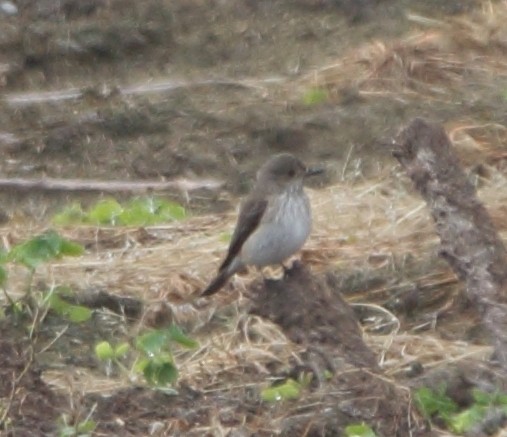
left=219, top=198, right=268, bottom=271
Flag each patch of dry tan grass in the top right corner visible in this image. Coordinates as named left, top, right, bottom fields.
left=301, top=2, right=507, bottom=100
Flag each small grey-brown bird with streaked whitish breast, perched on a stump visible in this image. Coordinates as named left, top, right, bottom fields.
left=201, top=153, right=323, bottom=296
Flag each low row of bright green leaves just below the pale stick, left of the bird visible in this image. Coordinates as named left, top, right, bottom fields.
left=53, top=197, right=187, bottom=226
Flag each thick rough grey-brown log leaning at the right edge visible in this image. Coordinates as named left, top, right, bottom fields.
left=393, top=118, right=507, bottom=371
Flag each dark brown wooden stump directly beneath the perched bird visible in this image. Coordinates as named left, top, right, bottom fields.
left=250, top=264, right=416, bottom=437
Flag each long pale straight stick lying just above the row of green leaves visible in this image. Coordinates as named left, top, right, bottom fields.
left=0, top=178, right=223, bottom=193
